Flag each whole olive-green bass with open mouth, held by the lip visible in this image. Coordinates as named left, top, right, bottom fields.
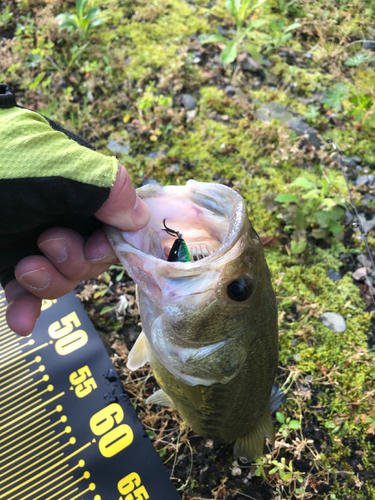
left=107, top=180, right=280, bottom=460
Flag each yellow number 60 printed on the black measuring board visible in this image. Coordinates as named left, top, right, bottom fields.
left=90, top=403, right=134, bottom=458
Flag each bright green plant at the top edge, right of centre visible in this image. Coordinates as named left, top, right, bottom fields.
left=201, top=0, right=267, bottom=64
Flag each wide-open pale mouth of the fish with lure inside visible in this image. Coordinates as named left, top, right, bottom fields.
left=107, top=180, right=247, bottom=276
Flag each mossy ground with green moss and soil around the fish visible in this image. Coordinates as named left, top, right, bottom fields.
left=0, top=0, right=375, bottom=500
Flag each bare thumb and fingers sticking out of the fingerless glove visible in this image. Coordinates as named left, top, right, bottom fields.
left=5, top=165, right=150, bottom=336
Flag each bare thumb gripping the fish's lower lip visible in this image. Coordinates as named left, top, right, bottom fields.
left=94, top=164, right=150, bottom=231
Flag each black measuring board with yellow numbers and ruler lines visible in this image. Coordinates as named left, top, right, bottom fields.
left=0, top=288, right=181, bottom=500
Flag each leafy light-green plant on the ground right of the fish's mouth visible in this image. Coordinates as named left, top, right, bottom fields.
left=263, top=177, right=345, bottom=254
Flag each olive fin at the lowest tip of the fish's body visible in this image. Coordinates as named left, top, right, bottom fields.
left=233, top=410, right=275, bottom=462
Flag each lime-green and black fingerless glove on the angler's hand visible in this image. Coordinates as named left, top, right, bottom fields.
left=0, top=84, right=118, bottom=287
